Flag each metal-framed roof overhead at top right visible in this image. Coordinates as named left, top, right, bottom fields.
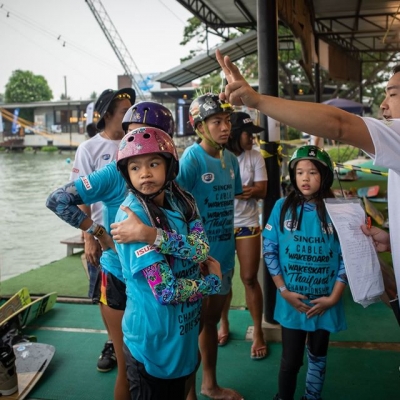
left=156, top=0, right=400, bottom=86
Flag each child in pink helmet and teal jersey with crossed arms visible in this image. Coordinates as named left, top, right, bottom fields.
left=116, top=127, right=222, bottom=400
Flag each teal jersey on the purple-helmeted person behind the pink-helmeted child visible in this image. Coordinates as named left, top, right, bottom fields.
left=74, top=161, right=128, bottom=281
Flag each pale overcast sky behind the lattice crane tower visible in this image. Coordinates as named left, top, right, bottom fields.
left=0, top=0, right=216, bottom=100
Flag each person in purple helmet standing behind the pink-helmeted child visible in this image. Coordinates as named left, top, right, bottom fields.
left=46, top=101, right=202, bottom=400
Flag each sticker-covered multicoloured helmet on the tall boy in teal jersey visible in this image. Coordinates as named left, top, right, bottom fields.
left=189, top=93, right=233, bottom=128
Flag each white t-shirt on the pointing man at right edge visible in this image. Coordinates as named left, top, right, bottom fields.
left=363, top=118, right=400, bottom=304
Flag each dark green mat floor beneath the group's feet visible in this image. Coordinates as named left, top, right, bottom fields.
left=18, top=302, right=400, bottom=400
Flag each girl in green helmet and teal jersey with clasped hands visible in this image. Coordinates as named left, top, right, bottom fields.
left=263, top=146, right=347, bottom=400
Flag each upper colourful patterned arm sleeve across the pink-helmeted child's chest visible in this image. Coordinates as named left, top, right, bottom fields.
left=156, top=217, right=210, bottom=263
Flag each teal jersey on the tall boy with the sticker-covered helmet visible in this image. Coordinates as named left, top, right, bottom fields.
left=176, top=143, right=243, bottom=274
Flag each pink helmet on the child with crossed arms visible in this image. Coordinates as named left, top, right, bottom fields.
left=117, top=127, right=179, bottom=190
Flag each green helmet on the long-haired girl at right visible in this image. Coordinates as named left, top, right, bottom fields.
left=289, top=146, right=333, bottom=190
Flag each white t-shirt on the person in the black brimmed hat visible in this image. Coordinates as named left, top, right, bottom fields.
left=69, top=134, right=120, bottom=224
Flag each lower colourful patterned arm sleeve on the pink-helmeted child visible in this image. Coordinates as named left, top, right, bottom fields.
left=142, top=261, right=221, bottom=305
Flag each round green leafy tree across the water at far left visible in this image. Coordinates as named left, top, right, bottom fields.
left=4, top=70, right=53, bottom=103
